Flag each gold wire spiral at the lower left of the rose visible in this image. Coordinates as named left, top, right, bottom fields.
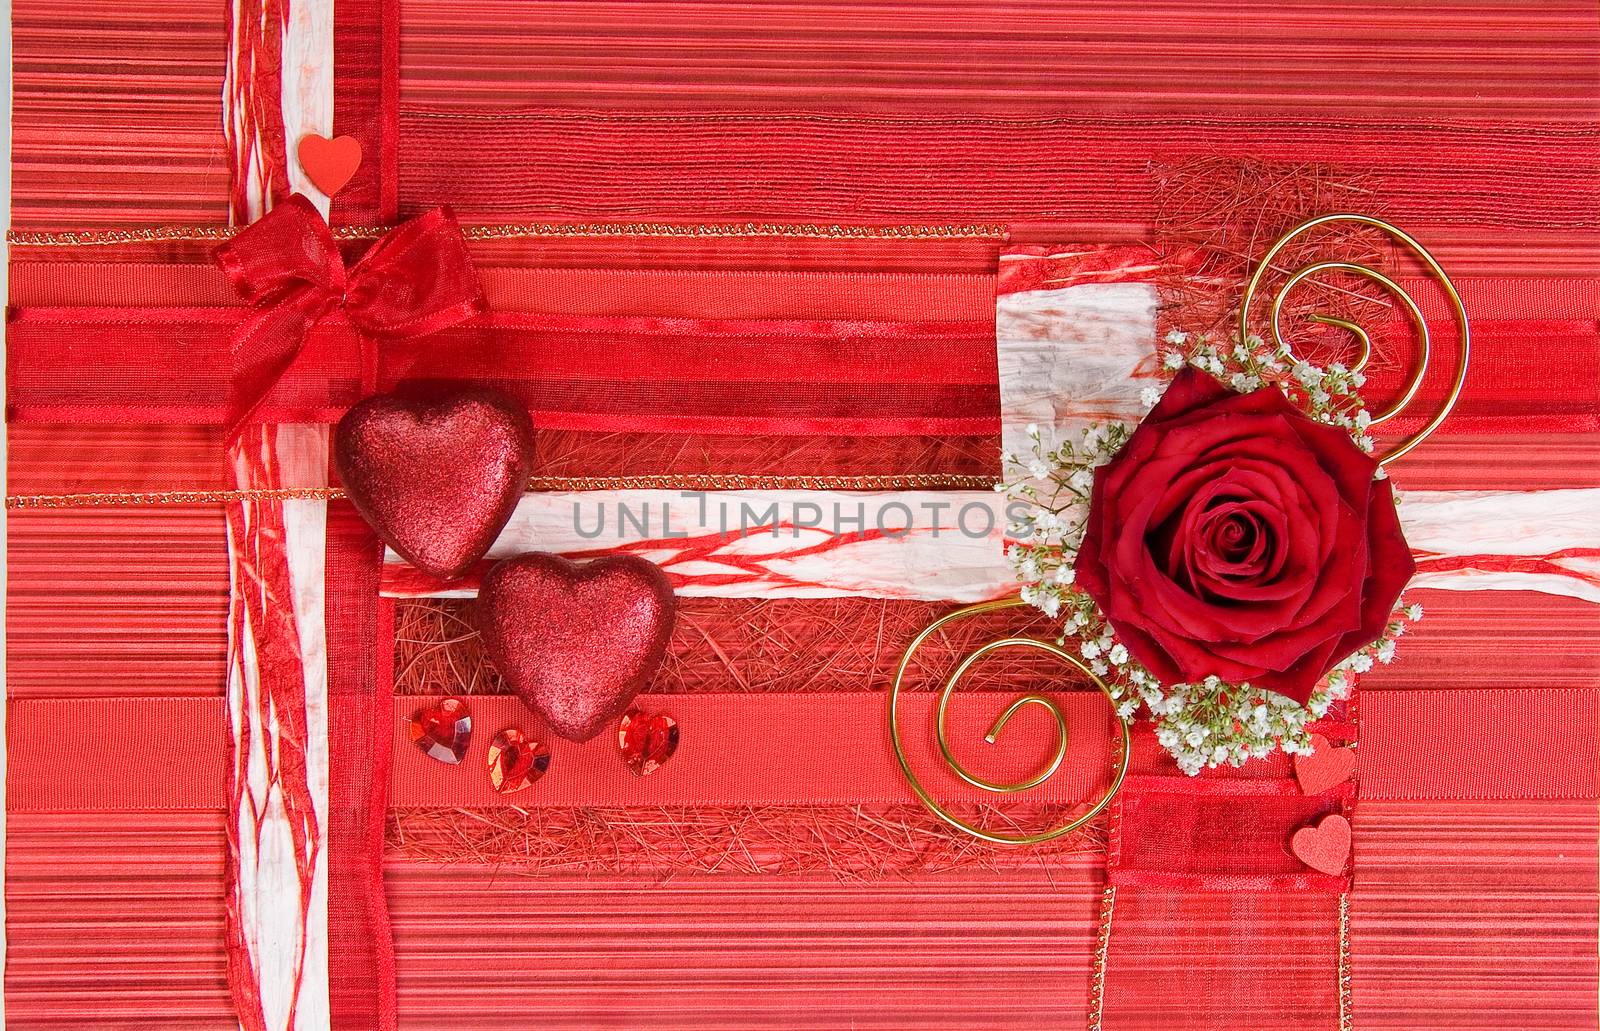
left=888, top=599, right=1133, bottom=845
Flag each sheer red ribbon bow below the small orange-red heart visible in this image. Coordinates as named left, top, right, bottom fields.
left=216, top=194, right=488, bottom=435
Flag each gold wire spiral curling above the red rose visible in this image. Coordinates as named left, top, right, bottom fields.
left=1238, top=213, right=1472, bottom=466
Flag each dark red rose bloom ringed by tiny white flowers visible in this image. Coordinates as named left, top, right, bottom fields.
left=1074, top=368, right=1414, bottom=703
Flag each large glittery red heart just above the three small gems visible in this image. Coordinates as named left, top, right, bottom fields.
left=477, top=554, right=677, bottom=741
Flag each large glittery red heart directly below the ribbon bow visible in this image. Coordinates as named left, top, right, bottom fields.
left=333, top=391, right=533, bottom=580
